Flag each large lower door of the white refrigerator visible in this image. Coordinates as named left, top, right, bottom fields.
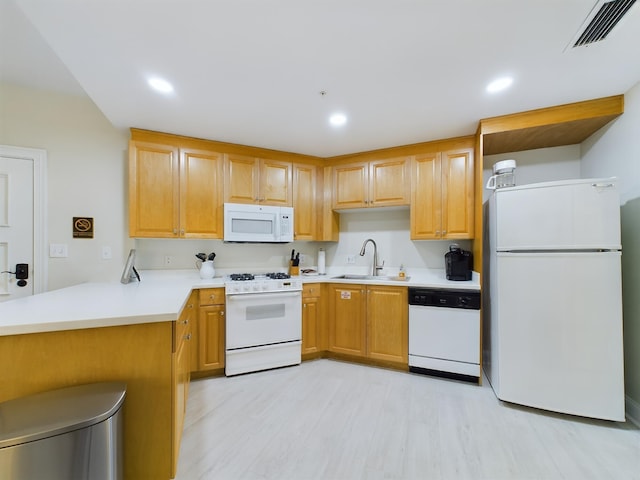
left=491, top=252, right=625, bottom=421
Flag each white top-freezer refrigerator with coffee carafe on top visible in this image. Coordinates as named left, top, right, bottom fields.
left=483, top=179, right=625, bottom=421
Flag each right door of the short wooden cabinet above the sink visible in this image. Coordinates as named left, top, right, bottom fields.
left=367, top=157, right=410, bottom=207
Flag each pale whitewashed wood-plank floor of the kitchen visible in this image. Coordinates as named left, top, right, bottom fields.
left=176, top=360, right=640, bottom=480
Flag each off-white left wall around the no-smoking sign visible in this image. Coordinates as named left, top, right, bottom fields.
left=0, top=83, right=132, bottom=290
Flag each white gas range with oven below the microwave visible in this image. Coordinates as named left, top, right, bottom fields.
left=225, top=273, right=302, bottom=376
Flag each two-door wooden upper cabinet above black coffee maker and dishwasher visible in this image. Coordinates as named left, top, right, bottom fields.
left=411, top=148, right=475, bottom=240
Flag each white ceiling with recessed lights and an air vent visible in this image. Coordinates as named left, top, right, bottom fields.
left=0, top=0, right=640, bottom=157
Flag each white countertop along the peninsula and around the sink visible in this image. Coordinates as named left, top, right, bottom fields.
left=0, top=269, right=480, bottom=336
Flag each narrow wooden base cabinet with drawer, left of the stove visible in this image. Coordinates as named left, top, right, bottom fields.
left=191, top=288, right=225, bottom=372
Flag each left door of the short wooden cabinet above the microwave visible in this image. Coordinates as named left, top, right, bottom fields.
left=224, top=154, right=260, bottom=203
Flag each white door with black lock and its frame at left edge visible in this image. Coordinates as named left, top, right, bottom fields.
left=0, top=146, right=46, bottom=302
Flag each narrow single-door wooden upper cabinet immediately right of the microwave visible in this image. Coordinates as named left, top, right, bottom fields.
left=293, top=163, right=318, bottom=240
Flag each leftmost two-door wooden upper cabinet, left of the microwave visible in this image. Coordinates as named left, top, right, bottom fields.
left=129, top=141, right=222, bottom=238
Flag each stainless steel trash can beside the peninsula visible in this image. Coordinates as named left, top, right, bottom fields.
left=0, top=382, right=126, bottom=480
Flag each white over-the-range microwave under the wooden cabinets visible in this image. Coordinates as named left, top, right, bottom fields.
left=224, top=203, right=293, bottom=243
